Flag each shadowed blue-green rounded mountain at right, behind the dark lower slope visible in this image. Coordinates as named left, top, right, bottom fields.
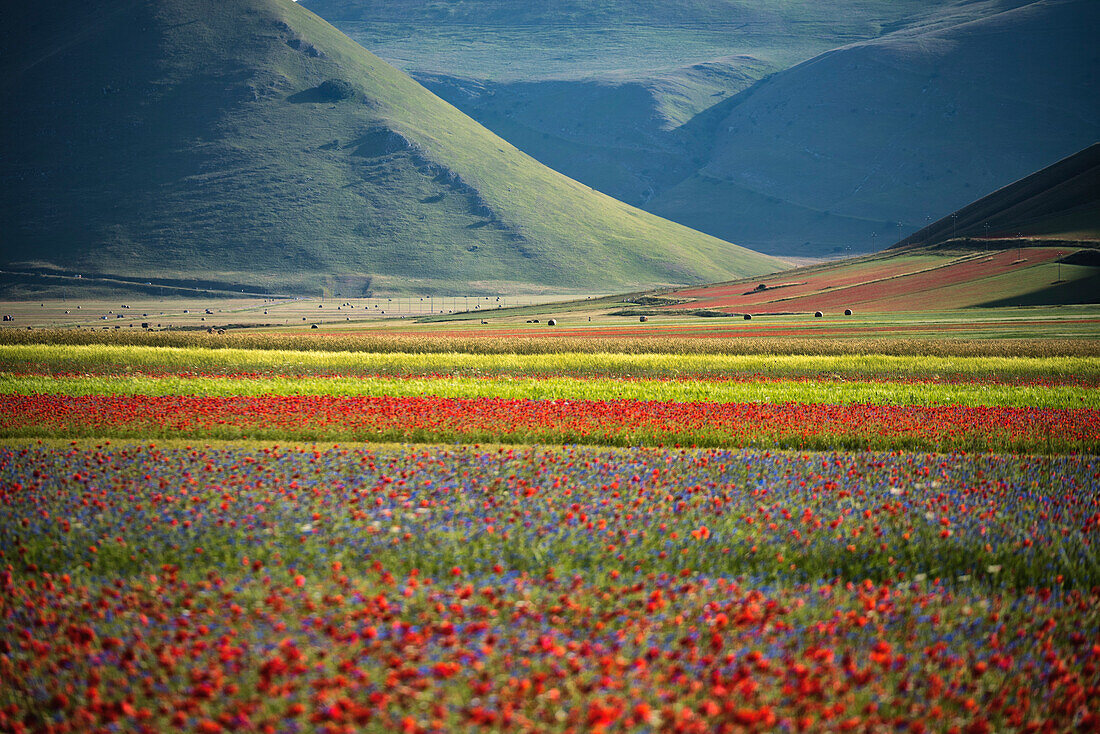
left=647, top=0, right=1100, bottom=254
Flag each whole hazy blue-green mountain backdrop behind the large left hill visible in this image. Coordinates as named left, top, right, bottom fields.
left=307, top=0, right=1100, bottom=256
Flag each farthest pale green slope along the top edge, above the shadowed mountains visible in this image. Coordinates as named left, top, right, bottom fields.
left=303, top=0, right=958, bottom=83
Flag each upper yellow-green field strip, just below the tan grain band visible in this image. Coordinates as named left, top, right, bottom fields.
left=0, top=344, right=1100, bottom=384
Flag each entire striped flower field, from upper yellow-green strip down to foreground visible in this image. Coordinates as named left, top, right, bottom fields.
left=0, top=336, right=1100, bottom=733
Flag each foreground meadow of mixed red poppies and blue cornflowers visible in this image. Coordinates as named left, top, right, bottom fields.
left=0, top=445, right=1100, bottom=732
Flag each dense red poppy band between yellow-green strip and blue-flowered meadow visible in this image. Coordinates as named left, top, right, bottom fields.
left=0, top=395, right=1100, bottom=452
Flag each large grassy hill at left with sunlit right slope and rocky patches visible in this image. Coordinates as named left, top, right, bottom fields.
left=0, top=0, right=782, bottom=296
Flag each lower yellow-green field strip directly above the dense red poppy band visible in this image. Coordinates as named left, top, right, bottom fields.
left=0, top=374, right=1100, bottom=408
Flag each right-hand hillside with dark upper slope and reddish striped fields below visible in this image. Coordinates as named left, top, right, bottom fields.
left=638, top=143, right=1100, bottom=317
